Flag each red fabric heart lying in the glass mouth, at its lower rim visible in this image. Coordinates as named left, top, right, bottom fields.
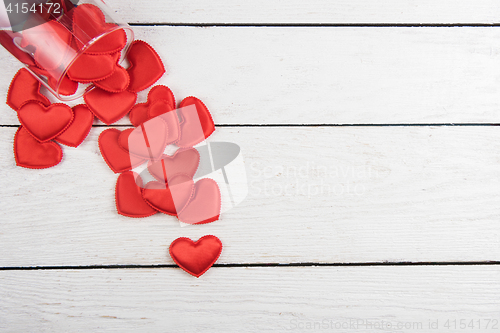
left=67, top=54, right=116, bottom=83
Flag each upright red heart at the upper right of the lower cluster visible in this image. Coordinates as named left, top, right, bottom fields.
left=176, top=96, right=215, bottom=147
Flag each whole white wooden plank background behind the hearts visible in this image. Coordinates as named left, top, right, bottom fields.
left=0, top=0, right=500, bottom=332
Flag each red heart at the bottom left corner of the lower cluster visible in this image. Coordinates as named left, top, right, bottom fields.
left=115, top=171, right=156, bottom=217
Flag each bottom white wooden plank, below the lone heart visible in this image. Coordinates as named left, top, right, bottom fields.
left=0, top=266, right=500, bottom=333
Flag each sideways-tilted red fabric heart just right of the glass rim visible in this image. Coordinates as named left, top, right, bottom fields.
left=127, top=40, right=165, bottom=92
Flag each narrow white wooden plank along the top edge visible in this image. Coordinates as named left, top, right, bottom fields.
left=106, top=0, right=500, bottom=24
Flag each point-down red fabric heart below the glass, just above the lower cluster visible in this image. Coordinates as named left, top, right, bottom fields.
left=83, top=88, right=137, bottom=125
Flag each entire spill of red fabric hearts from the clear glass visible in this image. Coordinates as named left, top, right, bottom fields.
left=5, top=7, right=222, bottom=277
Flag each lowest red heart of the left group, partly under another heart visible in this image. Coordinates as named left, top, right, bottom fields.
left=14, top=126, right=62, bottom=169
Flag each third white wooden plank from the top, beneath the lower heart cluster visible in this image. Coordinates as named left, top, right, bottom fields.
left=0, top=127, right=500, bottom=266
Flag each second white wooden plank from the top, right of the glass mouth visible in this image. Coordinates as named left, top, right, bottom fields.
left=0, top=27, right=500, bottom=124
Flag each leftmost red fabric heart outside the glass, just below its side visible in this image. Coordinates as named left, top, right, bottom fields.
left=7, top=68, right=50, bottom=111
